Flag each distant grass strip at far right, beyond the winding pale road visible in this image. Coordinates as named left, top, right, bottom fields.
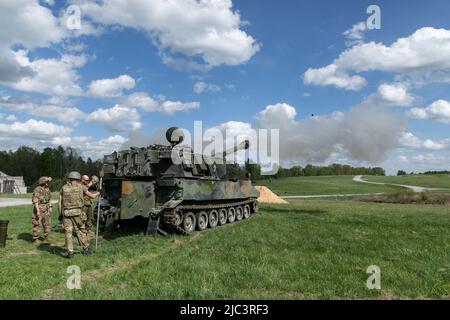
left=364, top=174, right=450, bottom=189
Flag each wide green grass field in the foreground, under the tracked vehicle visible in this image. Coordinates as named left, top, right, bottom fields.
left=0, top=200, right=450, bottom=299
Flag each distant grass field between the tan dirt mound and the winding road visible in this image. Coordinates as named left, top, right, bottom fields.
left=255, top=176, right=404, bottom=196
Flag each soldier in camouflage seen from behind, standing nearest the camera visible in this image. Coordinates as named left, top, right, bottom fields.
left=58, top=171, right=96, bottom=258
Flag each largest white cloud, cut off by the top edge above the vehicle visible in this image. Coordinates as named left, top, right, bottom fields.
left=71, top=0, right=260, bottom=67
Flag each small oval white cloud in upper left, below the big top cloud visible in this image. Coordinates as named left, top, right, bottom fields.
left=89, top=74, right=136, bottom=98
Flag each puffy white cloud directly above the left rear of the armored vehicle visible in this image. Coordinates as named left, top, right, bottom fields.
left=86, top=105, right=142, bottom=132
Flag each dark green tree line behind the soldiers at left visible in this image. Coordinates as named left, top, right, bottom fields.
left=0, top=146, right=102, bottom=192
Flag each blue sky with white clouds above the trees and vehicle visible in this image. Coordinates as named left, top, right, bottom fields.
left=0, top=0, right=450, bottom=173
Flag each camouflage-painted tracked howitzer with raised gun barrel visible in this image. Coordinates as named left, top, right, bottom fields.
left=100, top=128, right=259, bottom=235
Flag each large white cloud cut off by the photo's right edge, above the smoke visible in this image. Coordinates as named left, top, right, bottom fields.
left=304, top=27, right=450, bottom=90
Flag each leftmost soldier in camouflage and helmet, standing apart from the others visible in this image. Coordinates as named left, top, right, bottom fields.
left=32, top=177, right=52, bottom=243
